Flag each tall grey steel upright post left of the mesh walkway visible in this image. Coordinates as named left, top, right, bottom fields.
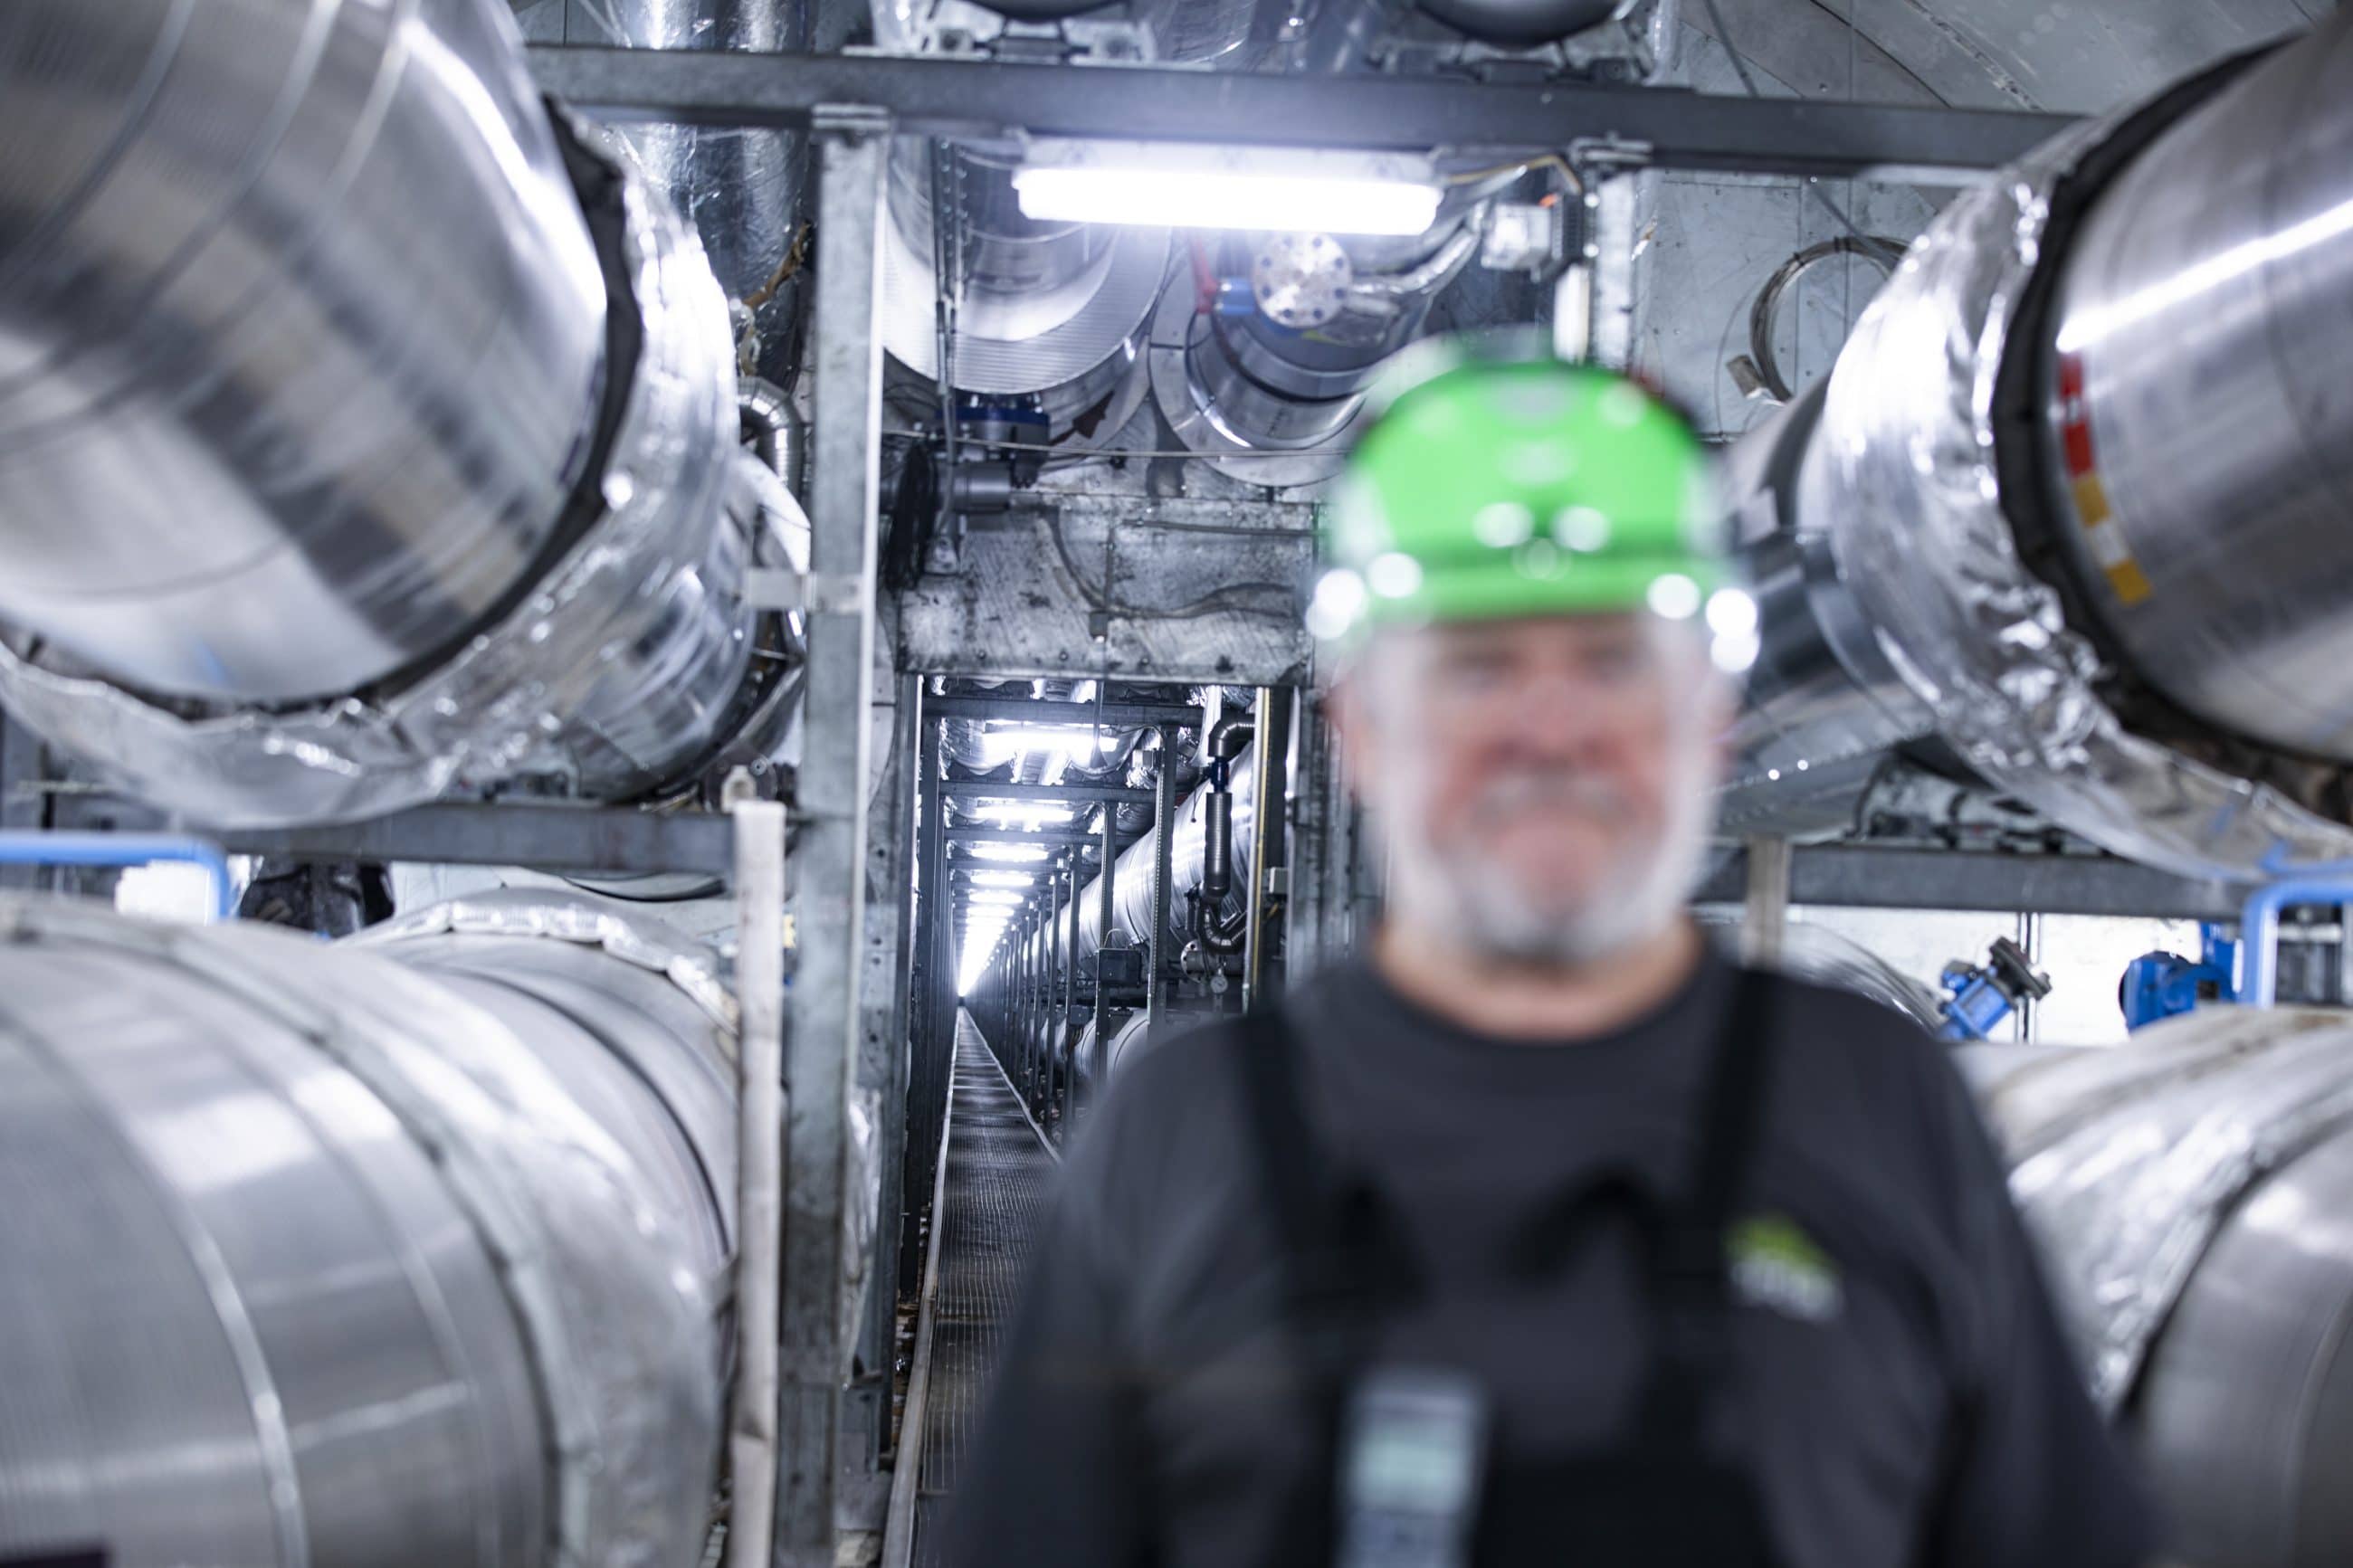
left=776, top=109, right=891, bottom=1568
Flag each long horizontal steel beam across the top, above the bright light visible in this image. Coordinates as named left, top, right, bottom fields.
left=529, top=44, right=2073, bottom=178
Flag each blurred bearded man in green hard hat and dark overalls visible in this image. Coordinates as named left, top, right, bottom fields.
left=948, top=360, right=2150, bottom=1568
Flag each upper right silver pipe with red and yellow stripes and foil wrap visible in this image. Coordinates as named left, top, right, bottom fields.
left=1727, top=12, right=2353, bottom=877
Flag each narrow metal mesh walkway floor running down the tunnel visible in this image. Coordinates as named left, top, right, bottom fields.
left=913, top=1013, right=1054, bottom=1568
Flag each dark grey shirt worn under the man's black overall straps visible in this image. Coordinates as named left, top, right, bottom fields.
left=946, top=956, right=2153, bottom=1568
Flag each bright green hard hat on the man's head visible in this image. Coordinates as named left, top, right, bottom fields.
left=1309, top=341, right=1753, bottom=644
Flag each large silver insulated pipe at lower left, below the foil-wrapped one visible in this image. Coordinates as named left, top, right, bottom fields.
left=0, top=896, right=734, bottom=1568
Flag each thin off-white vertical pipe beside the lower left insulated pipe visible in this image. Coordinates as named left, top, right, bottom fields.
left=727, top=799, right=784, bottom=1568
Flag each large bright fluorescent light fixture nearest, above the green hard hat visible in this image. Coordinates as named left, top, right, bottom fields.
left=1015, top=138, right=1443, bottom=235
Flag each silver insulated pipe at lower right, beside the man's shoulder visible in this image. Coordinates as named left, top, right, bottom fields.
left=1965, top=1006, right=2353, bottom=1568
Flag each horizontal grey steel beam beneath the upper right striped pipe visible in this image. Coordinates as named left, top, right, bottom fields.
left=1694, top=844, right=2247, bottom=919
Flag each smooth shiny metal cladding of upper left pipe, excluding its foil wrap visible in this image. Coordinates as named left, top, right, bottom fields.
left=0, top=0, right=605, bottom=700
